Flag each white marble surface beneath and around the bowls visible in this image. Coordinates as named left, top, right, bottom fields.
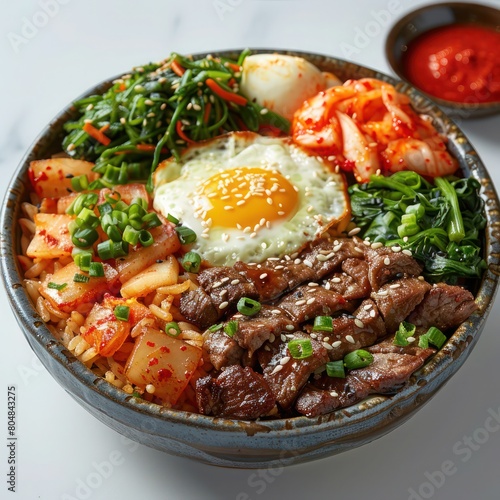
left=0, top=0, right=500, bottom=500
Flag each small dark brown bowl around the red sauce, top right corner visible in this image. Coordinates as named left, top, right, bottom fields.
left=385, top=2, right=500, bottom=119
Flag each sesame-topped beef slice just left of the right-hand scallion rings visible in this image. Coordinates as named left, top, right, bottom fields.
left=310, top=299, right=387, bottom=361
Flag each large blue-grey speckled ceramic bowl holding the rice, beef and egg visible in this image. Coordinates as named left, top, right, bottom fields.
left=0, top=50, right=500, bottom=468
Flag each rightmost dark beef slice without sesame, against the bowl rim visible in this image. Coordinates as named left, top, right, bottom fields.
left=408, top=283, right=478, bottom=330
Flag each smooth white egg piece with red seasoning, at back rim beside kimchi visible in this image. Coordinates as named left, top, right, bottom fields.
left=241, top=54, right=342, bottom=120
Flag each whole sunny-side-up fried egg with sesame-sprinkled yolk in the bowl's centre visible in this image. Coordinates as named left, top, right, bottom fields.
left=154, top=132, right=349, bottom=266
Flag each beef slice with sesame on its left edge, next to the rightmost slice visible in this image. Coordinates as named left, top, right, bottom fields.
left=371, top=276, right=431, bottom=333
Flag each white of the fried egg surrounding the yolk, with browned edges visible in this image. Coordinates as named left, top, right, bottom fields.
left=154, top=132, right=349, bottom=266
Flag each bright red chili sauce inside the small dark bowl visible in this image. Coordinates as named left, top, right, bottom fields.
left=403, top=24, right=500, bottom=103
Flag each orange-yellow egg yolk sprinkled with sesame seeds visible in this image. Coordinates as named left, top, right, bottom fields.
left=200, top=167, right=299, bottom=231
